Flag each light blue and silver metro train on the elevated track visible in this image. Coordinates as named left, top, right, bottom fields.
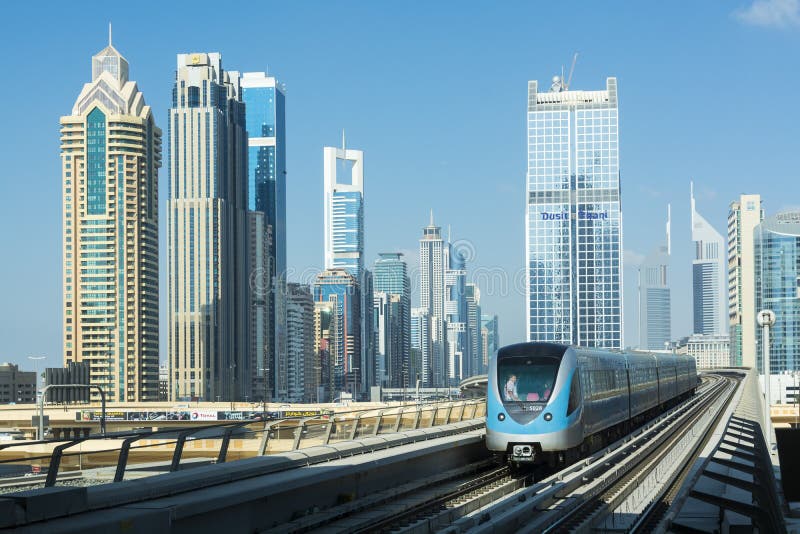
left=486, top=343, right=698, bottom=466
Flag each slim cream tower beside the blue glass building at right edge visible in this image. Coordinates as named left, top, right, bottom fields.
left=728, top=195, right=764, bottom=367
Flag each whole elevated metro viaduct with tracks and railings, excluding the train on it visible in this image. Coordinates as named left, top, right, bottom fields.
left=0, top=370, right=793, bottom=533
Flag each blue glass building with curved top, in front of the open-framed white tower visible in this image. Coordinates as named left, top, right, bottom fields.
left=314, top=268, right=360, bottom=398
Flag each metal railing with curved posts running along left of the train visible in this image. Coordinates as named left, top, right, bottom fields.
left=0, top=399, right=486, bottom=487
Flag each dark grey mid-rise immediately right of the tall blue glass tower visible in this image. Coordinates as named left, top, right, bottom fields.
left=286, top=283, right=315, bottom=402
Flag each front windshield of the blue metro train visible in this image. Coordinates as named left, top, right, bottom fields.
left=497, top=356, right=561, bottom=402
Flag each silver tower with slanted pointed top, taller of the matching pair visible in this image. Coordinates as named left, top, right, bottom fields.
left=691, top=183, right=728, bottom=335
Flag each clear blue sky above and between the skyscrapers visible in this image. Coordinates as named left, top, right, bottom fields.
left=0, top=0, right=800, bottom=372
